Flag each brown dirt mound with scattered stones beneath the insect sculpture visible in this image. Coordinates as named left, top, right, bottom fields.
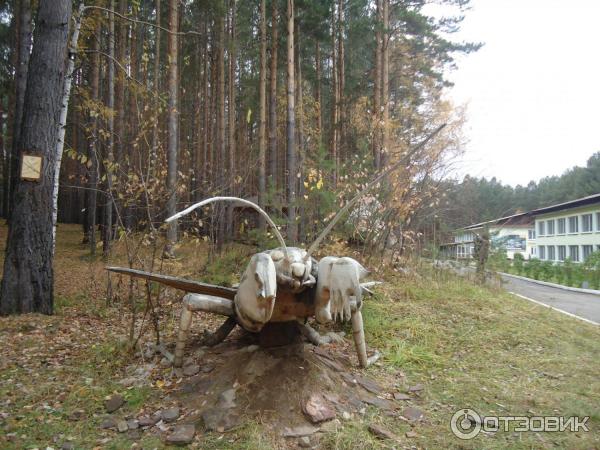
left=176, top=326, right=401, bottom=446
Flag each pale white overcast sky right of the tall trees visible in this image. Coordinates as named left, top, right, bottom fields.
left=434, top=0, right=600, bottom=185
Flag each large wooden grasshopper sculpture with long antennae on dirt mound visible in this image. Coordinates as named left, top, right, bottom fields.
left=108, top=127, right=442, bottom=367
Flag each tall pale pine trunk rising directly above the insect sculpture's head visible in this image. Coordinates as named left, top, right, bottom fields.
left=287, top=0, right=298, bottom=243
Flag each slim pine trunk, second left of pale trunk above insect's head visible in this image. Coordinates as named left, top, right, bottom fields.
left=258, top=0, right=267, bottom=230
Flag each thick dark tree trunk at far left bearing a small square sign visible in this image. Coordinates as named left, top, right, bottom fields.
left=0, top=0, right=71, bottom=314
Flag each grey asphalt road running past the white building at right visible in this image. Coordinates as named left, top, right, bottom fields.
left=502, top=276, right=600, bottom=324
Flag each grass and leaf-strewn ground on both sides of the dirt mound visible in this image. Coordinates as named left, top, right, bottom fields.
left=0, top=223, right=600, bottom=449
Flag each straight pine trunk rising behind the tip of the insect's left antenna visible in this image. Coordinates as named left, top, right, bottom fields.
left=165, top=0, right=179, bottom=257
